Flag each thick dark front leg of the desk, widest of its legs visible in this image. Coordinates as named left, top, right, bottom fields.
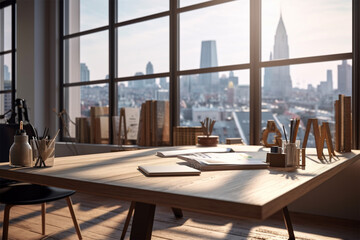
left=130, top=202, right=156, bottom=240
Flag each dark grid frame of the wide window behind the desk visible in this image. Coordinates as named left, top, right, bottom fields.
left=59, top=0, right=360, bottom=148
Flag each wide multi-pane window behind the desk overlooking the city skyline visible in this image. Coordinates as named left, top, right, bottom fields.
left=60, top=0, right=352, bottom=146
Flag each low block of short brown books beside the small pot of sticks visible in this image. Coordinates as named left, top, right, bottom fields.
left=173, top=126, right=204, bottom=146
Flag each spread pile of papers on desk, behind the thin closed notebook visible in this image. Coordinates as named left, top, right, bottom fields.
left=178, top=152, right=268, bottom=171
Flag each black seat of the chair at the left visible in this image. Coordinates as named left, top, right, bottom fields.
left=0, top=183, right=75, bottom=205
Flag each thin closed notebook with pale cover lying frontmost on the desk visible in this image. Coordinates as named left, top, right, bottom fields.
left=138, top=164, right=201, bottom=177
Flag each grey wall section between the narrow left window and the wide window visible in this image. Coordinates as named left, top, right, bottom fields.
left=16, top=0, right=58, bottom=137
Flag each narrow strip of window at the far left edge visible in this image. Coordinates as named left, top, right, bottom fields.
left=0, top=1, right=15, bottom=121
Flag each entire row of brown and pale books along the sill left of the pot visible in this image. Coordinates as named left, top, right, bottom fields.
left=76, top=103, right=208, bottom=146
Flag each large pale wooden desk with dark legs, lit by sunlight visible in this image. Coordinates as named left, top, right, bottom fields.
left=0, top=145, right=360, bottom=239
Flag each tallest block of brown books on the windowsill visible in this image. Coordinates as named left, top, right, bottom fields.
left=137, top=100, right=170, bottom=146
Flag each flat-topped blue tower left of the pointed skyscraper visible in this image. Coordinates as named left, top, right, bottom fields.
left=199, top=40, right=220, bottom=93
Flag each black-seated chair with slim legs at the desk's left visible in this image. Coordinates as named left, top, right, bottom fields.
left=0, top=183, right=82, bottom=240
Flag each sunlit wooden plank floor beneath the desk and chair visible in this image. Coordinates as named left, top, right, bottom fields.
left=0, top=193, right=360, bottom=240
